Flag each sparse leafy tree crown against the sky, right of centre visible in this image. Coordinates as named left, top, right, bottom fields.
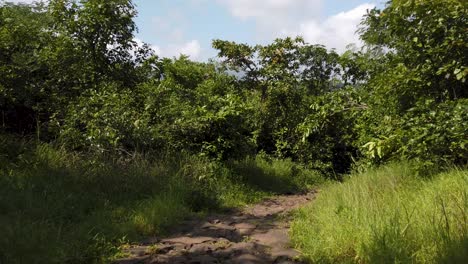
left=213, top=37, right=341, bottom=95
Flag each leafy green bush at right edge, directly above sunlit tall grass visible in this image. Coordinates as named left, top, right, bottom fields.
left=364, top=99, right=468, bottom=174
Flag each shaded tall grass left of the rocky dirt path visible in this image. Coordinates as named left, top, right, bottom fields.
left=0, top=134, right=315, bottom=263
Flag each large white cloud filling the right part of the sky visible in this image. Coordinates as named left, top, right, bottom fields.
left=217, top=0, right=375, bottom=51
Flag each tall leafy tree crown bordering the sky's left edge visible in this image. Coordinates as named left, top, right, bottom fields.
left=48, top=0, right=145, bottom=85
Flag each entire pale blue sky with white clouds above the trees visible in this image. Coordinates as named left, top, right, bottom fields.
left=9, top=0, right=384, bottom=61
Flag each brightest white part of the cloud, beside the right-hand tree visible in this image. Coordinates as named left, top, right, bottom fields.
left=296, top=4, right=375, bottom=52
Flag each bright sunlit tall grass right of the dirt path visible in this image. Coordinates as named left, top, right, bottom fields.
left=291, top=164, right=468, bottom=263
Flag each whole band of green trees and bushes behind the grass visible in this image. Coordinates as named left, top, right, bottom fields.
left=0, top=0, right=468, bottom=176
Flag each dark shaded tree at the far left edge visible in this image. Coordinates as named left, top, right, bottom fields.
left=0, top=3, right=51, bottom=133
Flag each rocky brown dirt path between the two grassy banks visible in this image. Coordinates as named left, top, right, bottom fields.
left=116, top=193, right=314, bottom=264
